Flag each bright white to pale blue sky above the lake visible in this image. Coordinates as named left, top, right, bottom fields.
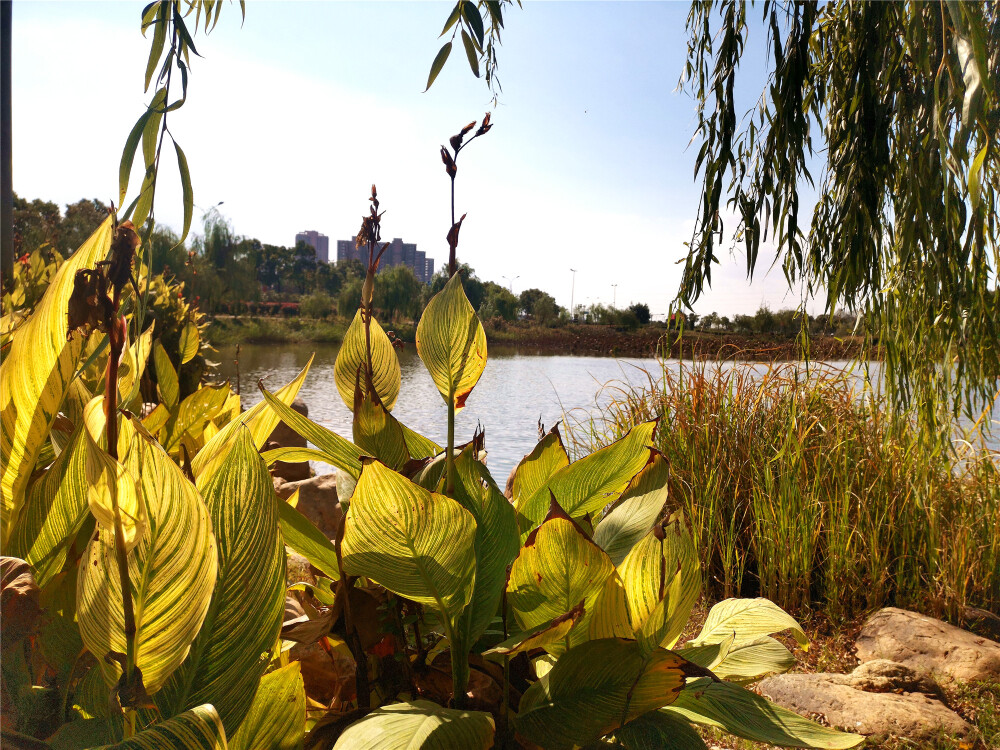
left=12, top=0, right=821, bottom=316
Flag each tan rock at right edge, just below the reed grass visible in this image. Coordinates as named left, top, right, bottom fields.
left=856, top=607, right=1000, bottom=682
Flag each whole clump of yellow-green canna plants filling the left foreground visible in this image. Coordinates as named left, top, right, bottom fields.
left=0, top=117, right=861, bottom=750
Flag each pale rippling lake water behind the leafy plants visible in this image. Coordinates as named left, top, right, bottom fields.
left=218, top=344, right=1000, bottom=487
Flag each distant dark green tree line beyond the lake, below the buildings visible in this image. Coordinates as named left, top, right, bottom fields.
left=5, top=195, right=855, bottom=336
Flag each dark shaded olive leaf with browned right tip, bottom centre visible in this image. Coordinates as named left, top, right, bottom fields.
left=515, top=638, right=700, bottom=750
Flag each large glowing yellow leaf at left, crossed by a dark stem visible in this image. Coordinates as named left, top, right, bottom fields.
left=77, top=420, right=218, bottom=695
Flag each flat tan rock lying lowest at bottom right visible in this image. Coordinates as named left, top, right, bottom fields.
left=758, top=674, right=975, bottom=740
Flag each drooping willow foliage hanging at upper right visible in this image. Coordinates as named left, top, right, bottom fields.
left=678, top=0, right=1000, bottom=434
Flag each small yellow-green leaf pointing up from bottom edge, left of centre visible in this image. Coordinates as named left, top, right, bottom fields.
left=229, top=661, right=306, bottom=750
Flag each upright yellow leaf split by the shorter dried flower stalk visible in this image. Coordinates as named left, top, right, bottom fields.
left=333, top=310, right=400, bottom=411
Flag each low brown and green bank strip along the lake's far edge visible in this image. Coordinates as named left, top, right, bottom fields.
left=206, top=315, right=878, bottom=362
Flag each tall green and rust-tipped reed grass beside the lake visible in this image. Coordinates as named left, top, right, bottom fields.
left=565, top=362, right=1000, bottom=619
